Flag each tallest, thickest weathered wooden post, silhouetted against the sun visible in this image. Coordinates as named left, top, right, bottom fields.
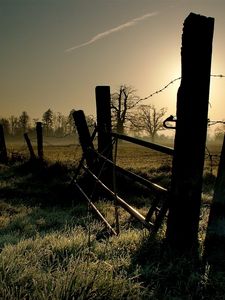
left=167, top=13, right=214, bottom=254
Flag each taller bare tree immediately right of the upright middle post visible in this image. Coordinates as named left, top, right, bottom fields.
left=111, top=85, right=140, bottom=134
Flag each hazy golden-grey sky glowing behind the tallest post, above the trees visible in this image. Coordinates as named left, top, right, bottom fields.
left=0, top=0, right=225, bottom=125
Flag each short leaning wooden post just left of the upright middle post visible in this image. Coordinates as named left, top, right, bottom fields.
left=73, top=110, right=94, bottom=170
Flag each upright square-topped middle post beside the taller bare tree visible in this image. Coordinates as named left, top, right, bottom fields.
left=95, top=86, right=113, bottom=187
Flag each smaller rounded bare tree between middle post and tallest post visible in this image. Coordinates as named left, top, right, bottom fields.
left=132, top=105, right=167, bottom=142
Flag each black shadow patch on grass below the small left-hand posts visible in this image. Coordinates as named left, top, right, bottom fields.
left=0, top=160, right=81, bottom=207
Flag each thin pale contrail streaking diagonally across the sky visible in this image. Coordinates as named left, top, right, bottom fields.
left=64, top=12, right=158, bottom=52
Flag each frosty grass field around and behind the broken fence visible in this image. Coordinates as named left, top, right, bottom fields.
left=0, top=139, right=225, bottom=299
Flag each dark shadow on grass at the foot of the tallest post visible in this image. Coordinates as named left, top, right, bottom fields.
left=128, top=229, right=225, bottom=300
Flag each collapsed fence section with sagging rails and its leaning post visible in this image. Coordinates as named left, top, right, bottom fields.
left=71, top=108, right=173, bottom=234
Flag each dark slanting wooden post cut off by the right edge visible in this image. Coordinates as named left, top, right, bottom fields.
left=204, top=136, right=225, bottom=271
